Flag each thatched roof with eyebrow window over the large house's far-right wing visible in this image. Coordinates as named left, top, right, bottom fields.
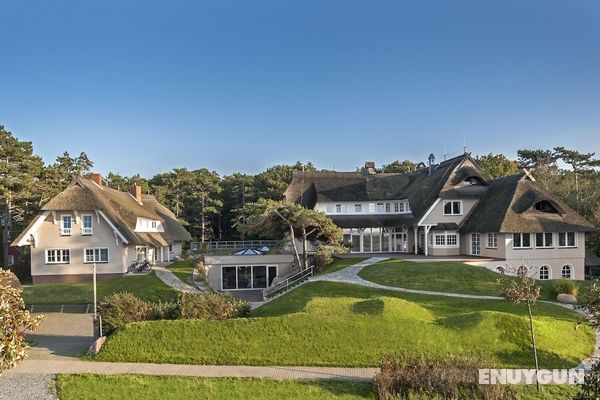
left=461, top=173, right=596, bottom=233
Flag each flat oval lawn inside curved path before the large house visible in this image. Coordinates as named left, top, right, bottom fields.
left=358, top=260, right=590, bottom=301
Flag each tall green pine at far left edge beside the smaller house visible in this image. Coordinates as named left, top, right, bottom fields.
left=0, top=125, right=43, bottom=266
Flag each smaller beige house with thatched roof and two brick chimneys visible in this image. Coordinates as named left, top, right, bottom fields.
left=13, top=174, right=190, bottom=284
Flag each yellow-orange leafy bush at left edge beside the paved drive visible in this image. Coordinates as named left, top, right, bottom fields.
left=0, top=270, right=43, bottom=374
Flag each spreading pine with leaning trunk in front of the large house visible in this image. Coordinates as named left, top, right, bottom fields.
left=236, top=199, right=342, bottom=268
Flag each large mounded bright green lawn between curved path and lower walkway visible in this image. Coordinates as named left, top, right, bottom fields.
left=95, top=282, right=594, bottom=368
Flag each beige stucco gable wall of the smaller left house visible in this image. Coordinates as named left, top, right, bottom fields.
left=31, top=211, right=126, bottom=277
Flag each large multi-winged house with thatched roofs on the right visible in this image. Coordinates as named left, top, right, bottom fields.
left=284, top=153, right=597, bottom=279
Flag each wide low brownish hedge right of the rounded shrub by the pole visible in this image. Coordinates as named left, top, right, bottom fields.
left=179, top=293, right=250, bottom=320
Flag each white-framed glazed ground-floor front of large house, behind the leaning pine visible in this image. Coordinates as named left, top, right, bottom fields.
left=344, top=227, right=412, bottom=253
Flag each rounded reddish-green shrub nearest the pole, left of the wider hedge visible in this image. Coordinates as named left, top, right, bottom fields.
left=98, top=292, right=152, bottom=334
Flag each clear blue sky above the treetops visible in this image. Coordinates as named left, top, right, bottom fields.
left=0, top=0, right=600, bottom=177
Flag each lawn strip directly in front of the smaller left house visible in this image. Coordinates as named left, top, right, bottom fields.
left=23, top=272, right=177, bottom=304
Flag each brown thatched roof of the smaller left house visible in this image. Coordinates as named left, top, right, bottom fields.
left=15, top=177, right=191, bottom=246
